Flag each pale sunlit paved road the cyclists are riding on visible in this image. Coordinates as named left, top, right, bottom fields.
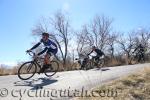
left=0, top=63, right=150, bottom=100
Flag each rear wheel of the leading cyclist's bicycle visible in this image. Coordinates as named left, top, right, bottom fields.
left=45, top=61, right=59, bottom=77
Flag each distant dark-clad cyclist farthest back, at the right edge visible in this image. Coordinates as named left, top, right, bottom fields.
left=133, top=44, right=145, bottom=62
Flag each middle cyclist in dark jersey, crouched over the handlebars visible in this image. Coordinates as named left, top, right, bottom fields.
left=88, top=46, right=105, bottom=62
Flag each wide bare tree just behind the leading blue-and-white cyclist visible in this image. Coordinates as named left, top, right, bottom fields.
left=32, top=12, right=70, bottom=68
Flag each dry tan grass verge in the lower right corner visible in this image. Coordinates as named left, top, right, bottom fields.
left=77, top=68, right=150, bottom=100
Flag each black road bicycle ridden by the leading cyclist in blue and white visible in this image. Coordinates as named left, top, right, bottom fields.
left=18, top=51, right=59, bottom=80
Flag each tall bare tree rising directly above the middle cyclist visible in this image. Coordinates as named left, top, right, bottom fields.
left=90, top=15, right=112, bottom=50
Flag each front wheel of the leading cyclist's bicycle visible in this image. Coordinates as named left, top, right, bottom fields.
left=18, top=61, right=37, bottom=80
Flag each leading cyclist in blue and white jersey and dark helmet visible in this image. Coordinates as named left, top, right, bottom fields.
left=27, top=33, right=58, bottom=73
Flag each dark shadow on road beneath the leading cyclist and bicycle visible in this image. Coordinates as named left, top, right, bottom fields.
left=14, top=78, right=57, bottom=90
